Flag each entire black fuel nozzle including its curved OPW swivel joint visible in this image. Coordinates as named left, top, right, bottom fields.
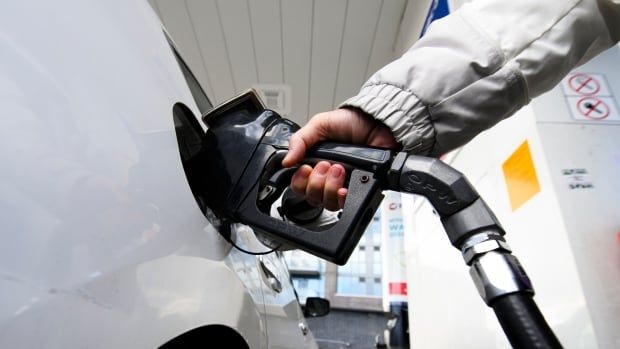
left=202, top=90, right=503, bottom=265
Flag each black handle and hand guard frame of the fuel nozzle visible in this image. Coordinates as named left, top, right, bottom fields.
left=226, top=139, right=392, bottom=265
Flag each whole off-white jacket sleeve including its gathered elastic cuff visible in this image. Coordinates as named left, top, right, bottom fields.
left=341, top=0, right=620, bottom=156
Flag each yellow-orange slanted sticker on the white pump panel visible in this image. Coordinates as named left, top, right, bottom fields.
left=502, top=141, right=540, bottom=211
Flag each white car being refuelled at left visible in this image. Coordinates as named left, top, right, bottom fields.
left=0, top=0, right=326, bottom=348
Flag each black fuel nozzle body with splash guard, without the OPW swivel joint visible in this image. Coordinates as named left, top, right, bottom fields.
left=202, top=90, right=393, bottom=265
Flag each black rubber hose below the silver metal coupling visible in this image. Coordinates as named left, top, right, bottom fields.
left=491, top=293, right=562, bottom=349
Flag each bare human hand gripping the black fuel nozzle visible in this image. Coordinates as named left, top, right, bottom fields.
left=282, top=108, right=399, bottom=211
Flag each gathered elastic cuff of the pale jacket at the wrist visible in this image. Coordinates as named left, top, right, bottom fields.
left=340, top=83, right=435, bottom=155
